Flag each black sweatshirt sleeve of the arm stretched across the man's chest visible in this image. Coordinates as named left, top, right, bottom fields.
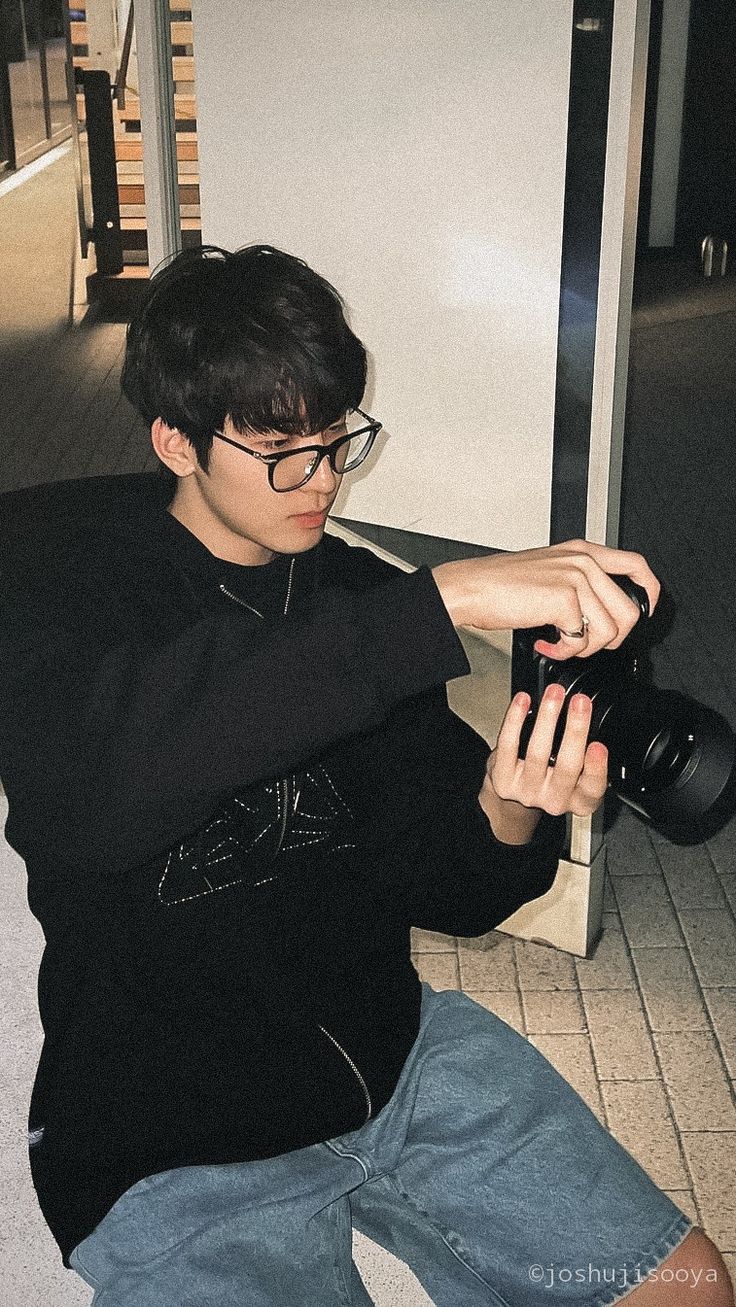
left=0, top=569, right=469, bottom=873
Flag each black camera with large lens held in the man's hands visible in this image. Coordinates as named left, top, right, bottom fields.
left=512, top=576, right=736, bottom=842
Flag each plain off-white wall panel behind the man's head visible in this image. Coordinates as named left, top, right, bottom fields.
left=193, top=0, right=571, bottom=549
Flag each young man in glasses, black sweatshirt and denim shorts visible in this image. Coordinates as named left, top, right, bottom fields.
left=0, top=247, right=731, bottom=1307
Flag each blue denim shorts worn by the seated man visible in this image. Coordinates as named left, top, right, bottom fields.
left=71, top=985, right=690, bottom=1307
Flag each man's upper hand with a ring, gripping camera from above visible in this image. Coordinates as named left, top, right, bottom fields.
left=433, top=540, right=660, bottom=660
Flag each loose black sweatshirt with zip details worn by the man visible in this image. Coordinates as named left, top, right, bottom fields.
left=0, top=477, right=563, bottom=1260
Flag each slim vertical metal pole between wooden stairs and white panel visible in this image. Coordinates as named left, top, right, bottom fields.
left=135, top=0, right=182, bottom=272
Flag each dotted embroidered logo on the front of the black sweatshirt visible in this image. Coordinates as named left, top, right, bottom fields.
left=158, top=763, right=356, bottom=904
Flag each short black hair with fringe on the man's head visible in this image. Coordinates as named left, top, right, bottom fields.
left=122, top=244, right=366, bottom=472
